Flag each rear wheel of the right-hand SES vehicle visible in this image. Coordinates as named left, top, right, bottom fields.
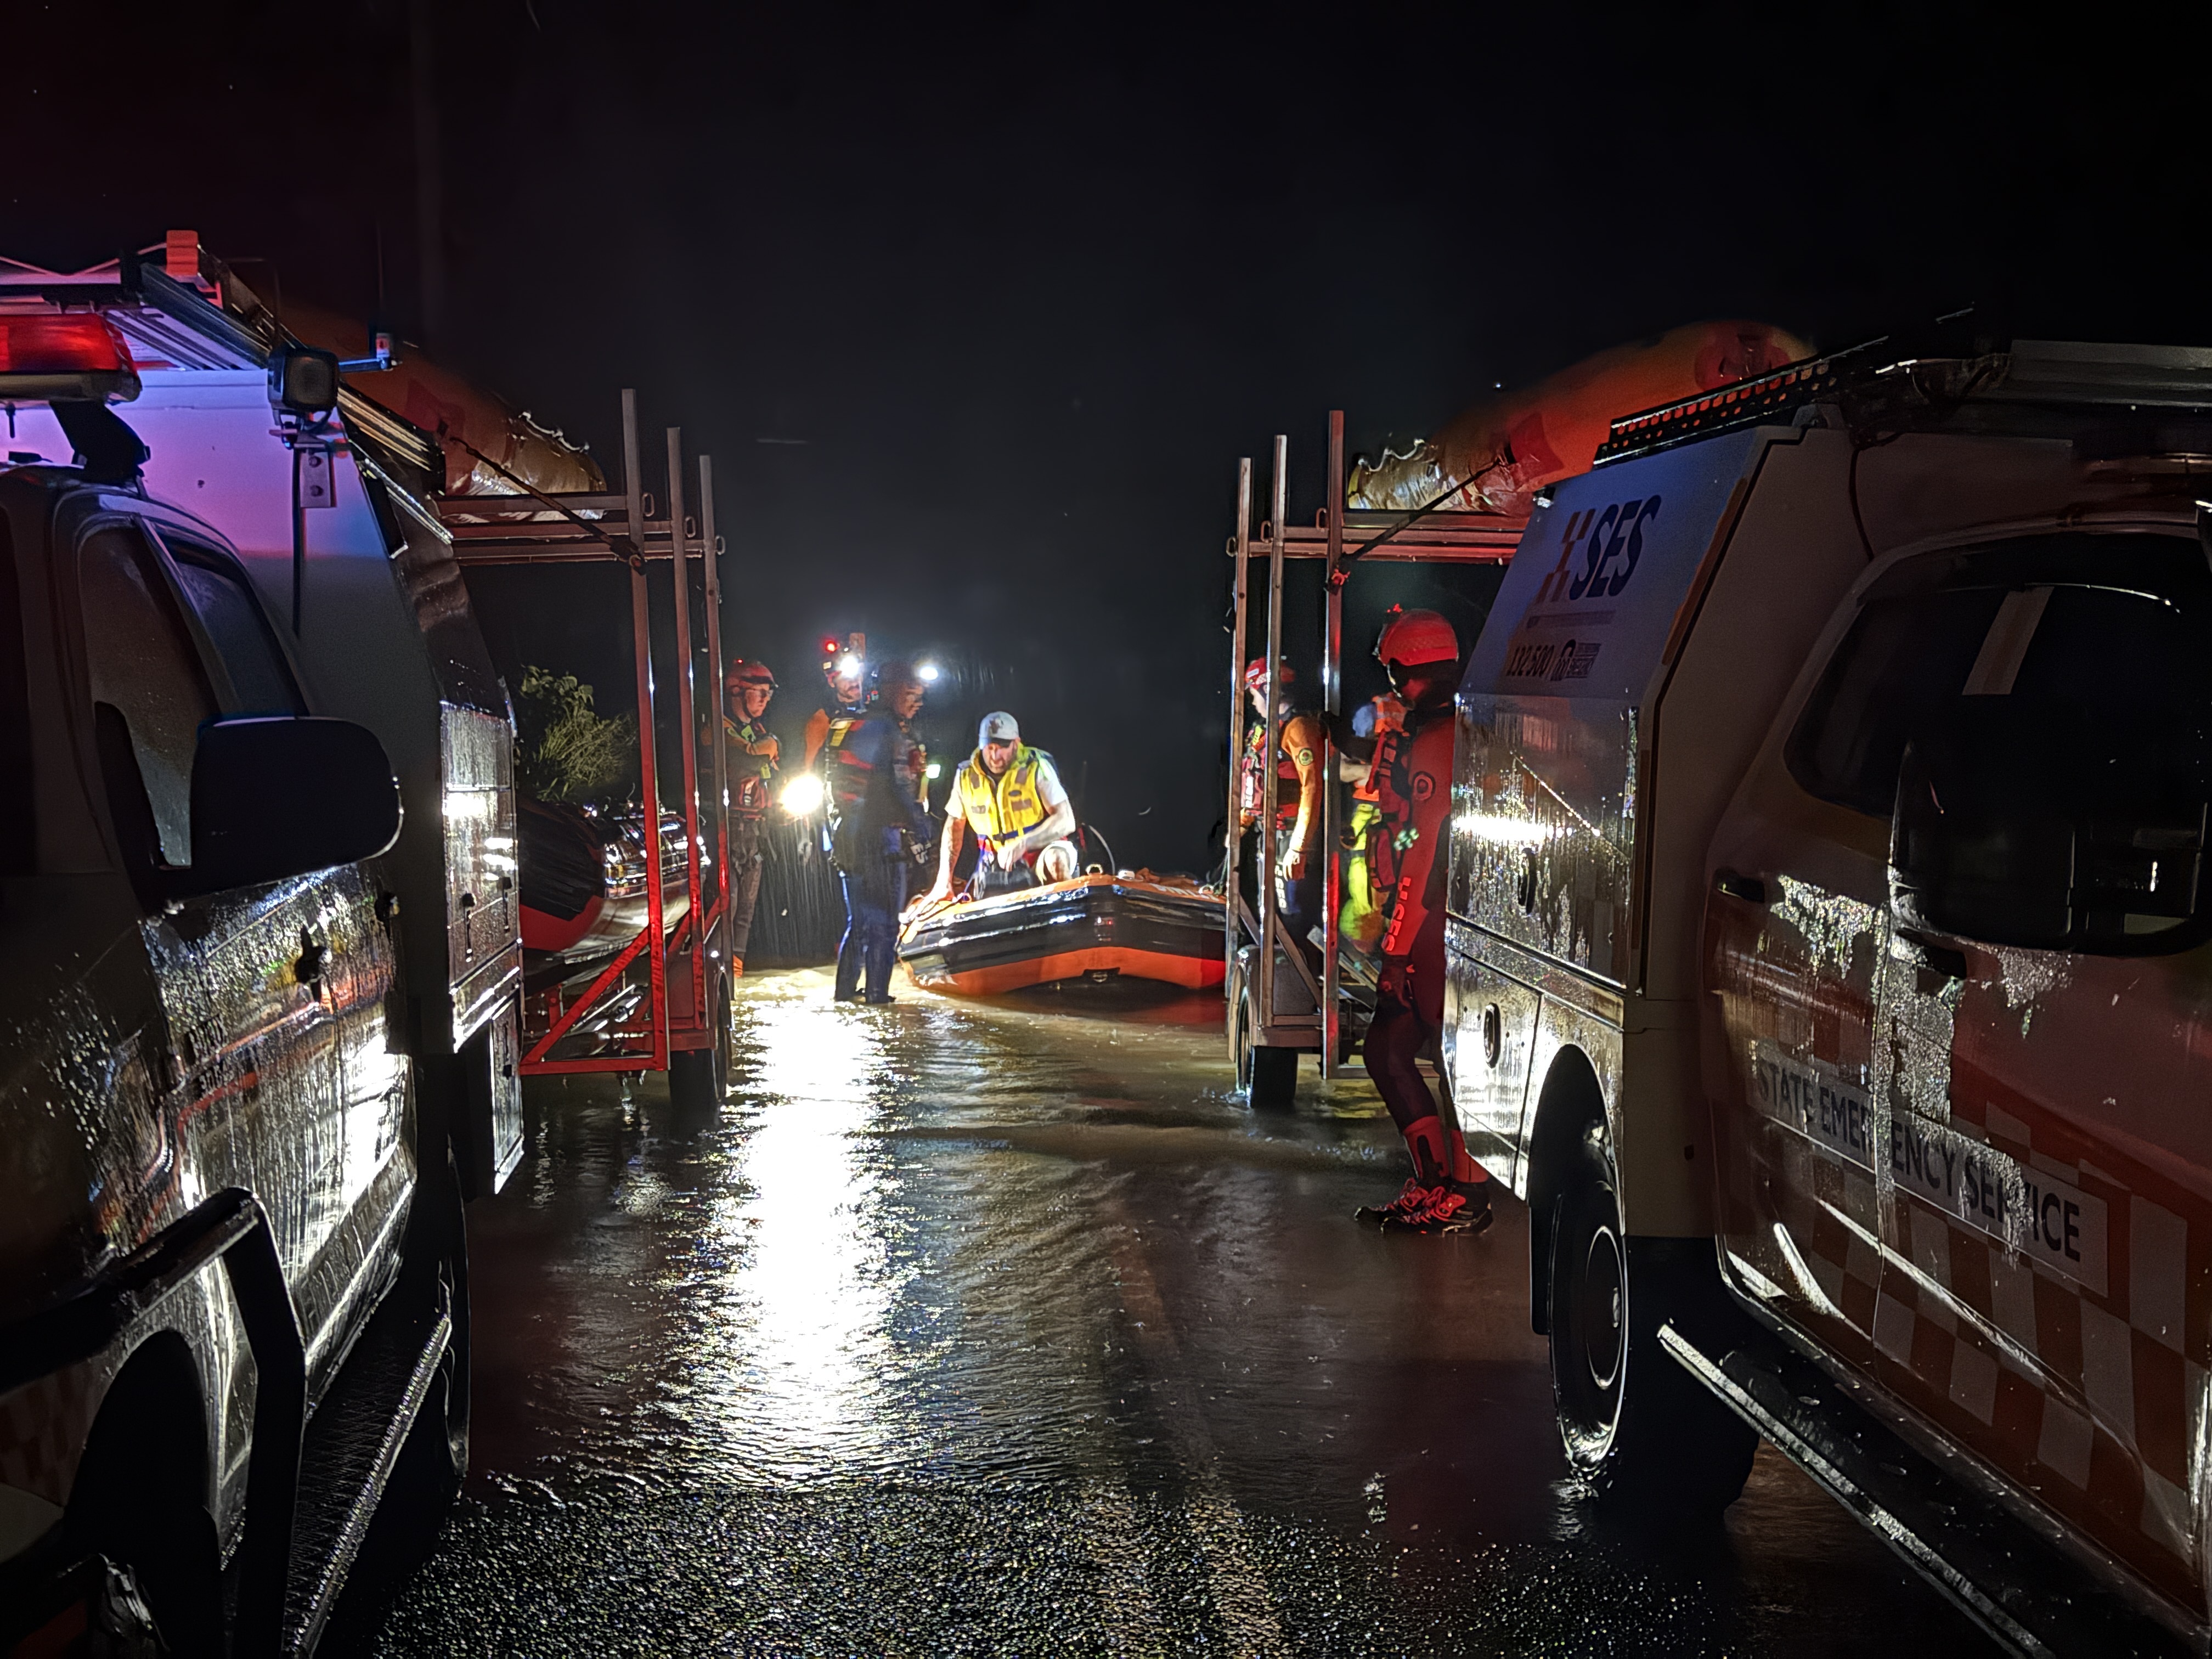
left=1548, top=1124, right=1758, bottom=1515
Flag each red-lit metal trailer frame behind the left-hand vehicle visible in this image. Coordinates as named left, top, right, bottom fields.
left=436, top=387, right=730, bottom=1075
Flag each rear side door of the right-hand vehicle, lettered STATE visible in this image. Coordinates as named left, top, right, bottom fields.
left=1703, top=560, right=2026, bottom=1365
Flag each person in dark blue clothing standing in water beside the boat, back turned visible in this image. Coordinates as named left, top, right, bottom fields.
left=827, top=662, right=929, bottom=1002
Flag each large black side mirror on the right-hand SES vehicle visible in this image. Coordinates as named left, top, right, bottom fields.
left=1889, top=697, right=2212, bottom=956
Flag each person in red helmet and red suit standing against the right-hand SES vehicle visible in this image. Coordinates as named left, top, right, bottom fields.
left=1345, top=608, right=1491, bottom=1232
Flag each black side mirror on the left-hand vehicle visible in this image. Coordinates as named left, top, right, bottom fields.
left=179, top=716, right=400, bottom=894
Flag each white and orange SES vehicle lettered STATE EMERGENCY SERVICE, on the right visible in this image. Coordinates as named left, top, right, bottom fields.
left=1444, top=341, right=2212, bottom=1652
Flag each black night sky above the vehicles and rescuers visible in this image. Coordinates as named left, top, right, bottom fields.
left=0, top=0, right=2212, bottom=867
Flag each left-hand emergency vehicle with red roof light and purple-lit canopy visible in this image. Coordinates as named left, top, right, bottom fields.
left=0, top=246, right=522, bottom=1655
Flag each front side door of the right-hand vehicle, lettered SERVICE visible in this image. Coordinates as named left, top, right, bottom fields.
left=1878, top=539, right=2212, bottom=1608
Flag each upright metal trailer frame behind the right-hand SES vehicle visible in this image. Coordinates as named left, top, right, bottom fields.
left=1223, top=409, right=1528, bottom=1077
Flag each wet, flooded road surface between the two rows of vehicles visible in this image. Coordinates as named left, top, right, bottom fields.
left=338, top=971, right=1987, bottom=1659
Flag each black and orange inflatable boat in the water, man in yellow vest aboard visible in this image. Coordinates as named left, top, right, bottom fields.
left=898, top=870, right=1226, bottom=995
